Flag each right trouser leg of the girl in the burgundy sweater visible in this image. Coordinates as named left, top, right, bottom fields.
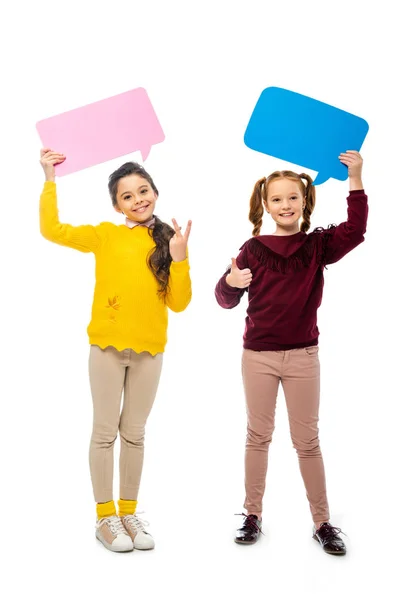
left=282, top=346, right=329, bottom=523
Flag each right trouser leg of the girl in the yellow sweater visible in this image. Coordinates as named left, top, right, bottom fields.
left=119, top=350, right=163, bottom=500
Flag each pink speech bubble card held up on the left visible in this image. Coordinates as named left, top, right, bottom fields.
left=36, top=88, right=165, bottom=177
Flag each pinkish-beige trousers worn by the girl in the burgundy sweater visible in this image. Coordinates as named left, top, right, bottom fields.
left=242, top=346, right=329, bottom=523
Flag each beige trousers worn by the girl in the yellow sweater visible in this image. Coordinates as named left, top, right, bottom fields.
left=89, top=346, right=163, bottom=502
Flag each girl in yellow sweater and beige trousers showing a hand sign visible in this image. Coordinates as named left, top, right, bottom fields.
left=40, top=148, right=192, bottom=552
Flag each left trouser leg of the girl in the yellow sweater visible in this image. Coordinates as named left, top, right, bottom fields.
left=89, top=346, right=126, bottom=503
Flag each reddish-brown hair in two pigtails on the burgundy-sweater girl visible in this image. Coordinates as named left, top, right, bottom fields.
left=249, top=171, right=315, bottom=236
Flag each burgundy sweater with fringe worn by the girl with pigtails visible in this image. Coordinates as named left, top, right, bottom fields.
left=215, top=190, right=368, bottom=350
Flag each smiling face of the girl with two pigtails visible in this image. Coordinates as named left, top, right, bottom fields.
left=265, top=177, right=306, bottom=235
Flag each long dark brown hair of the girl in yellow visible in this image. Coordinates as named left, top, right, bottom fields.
left=108, top=162, right=175, bottom=298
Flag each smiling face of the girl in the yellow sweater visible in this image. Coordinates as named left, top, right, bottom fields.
left=115, top=175, right=157, bottom=223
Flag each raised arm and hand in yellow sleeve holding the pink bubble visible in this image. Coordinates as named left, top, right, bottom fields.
left=39, top=148, right=101, bottom=252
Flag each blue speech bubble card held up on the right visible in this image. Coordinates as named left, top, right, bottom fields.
left=244, top=87, right=369, bottom=185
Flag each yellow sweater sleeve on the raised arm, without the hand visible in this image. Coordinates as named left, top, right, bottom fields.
left=39, top=181, right=101, bottom=252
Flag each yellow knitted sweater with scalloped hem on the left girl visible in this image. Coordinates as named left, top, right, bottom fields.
left=40, top=181, right=192, bottom=355
